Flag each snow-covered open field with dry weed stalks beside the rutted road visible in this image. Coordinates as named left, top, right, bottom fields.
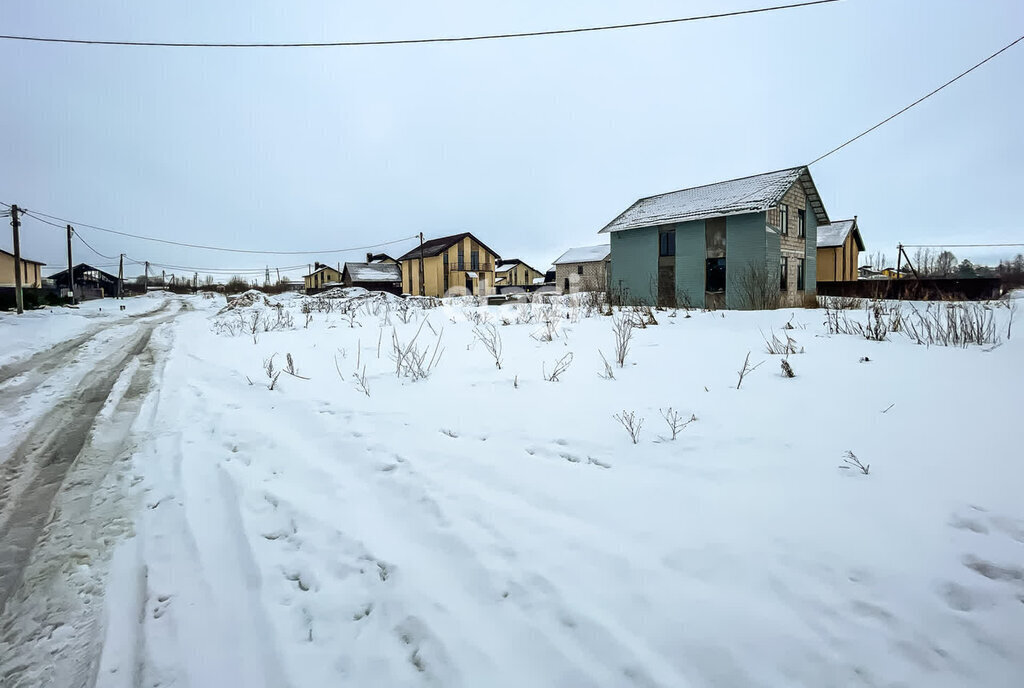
left=0, top=291, right=1024, bottom=688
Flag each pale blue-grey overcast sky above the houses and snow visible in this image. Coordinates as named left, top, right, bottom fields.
left=0, top=0, right=1024, bottom=276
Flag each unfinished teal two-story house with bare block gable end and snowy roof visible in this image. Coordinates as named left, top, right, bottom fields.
left=601, top=167, right=829, bottom=308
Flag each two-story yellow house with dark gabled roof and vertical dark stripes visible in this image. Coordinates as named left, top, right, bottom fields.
left=398, top=231, right=501, bottom=297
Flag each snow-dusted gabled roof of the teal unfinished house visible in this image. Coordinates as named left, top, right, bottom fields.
left=601, top=167, right=829, bottom=232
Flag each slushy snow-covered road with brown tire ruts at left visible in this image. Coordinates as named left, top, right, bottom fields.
left=0, top=301, right=187, bottom=686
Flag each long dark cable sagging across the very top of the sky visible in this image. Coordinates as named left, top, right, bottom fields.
left=0, top=0, right=840, bottom=48
